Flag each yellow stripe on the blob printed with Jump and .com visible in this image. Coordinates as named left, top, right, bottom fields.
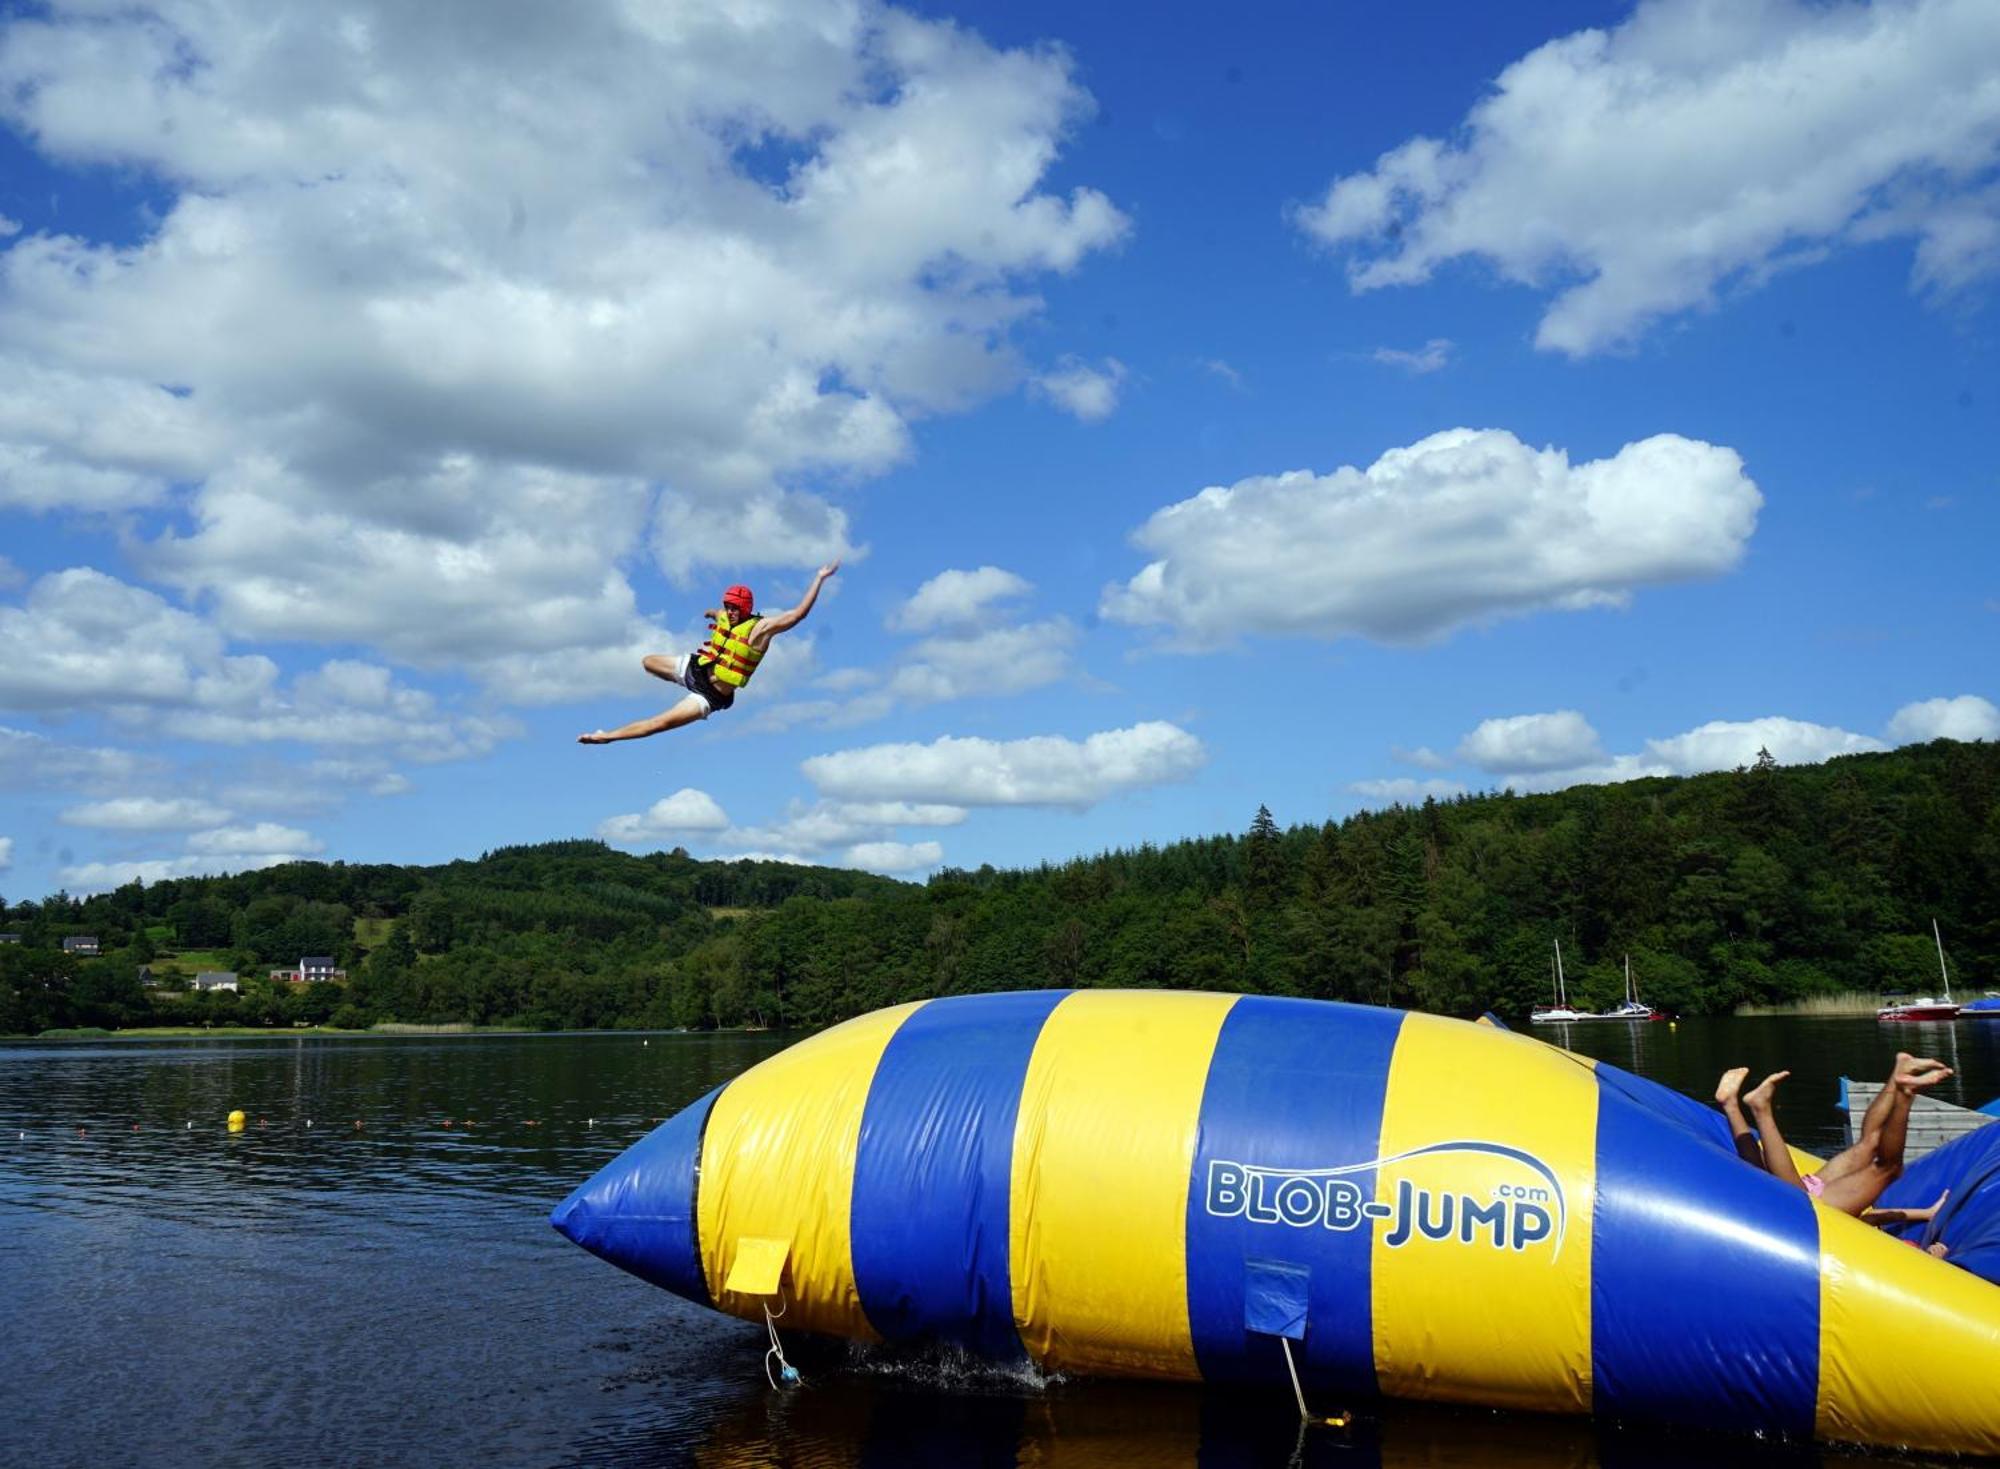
left=1370, top=1015, right=1598, bottom=1413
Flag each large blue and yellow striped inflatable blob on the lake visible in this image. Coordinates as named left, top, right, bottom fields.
left=552, top=991, right=2000, bottom=1453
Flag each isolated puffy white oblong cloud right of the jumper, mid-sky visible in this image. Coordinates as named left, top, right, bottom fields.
left=1102, top=428, right=1762, bottom=646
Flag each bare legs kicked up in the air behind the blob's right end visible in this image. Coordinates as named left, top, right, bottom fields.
left=1716, top=1051, right=1952, bottom=1255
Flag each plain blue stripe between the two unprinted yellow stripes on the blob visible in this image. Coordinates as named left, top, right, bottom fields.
left=850, top=991, right=1070, bottom=1357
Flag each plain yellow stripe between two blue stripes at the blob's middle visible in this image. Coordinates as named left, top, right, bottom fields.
left=1008, top=991, right=1236, bottom=1379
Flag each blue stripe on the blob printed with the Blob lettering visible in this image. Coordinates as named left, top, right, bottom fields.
left=1188, top=997, right=1402, bottom=1393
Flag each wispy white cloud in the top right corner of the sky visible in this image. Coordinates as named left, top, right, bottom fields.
left=1294, top=0, right=2000, bottom=356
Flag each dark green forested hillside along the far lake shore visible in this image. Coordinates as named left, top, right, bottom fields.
left=0, top=741, right=2000, bottom=1035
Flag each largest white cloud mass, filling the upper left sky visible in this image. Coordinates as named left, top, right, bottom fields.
left=0, top=0, right=1128, bottom=680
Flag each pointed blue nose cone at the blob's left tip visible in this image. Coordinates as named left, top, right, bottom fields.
left=548, top=1087, right=722, bottom=1305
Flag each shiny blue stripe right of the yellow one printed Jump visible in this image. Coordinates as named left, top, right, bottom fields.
left=1590, top=1069, right=1820, bottom=1437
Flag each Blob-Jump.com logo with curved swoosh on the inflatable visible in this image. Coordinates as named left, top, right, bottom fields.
left=1204, top=1139, right=1568, bottom=1265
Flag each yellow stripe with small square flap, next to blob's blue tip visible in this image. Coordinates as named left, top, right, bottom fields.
left=696, top=1005, right=916, bottom=1341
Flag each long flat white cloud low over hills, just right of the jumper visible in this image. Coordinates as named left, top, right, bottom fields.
left=802, top=720, right=1208, bottom=811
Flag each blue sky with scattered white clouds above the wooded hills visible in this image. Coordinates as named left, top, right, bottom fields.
left=0, top=0, right=2000, bottom=897
